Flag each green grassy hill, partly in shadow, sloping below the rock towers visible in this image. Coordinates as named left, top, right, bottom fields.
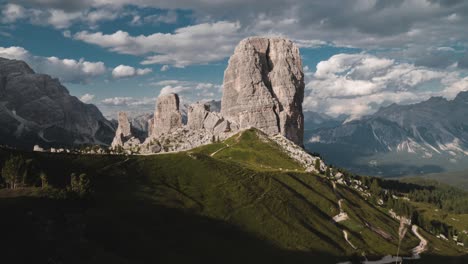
left=0, top=129, right=466, bottom=263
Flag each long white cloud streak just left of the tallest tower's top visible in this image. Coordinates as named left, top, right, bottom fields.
left=74, top=21, right=240, bottom=67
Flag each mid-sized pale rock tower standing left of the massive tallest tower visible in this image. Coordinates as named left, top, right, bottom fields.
left=152, top=94, right=182, bottom=136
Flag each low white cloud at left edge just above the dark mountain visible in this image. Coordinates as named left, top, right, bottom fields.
left=0, top=46, right=106, bottom=83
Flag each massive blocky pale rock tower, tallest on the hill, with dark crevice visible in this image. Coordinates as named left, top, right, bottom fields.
left=221, top=37, right=304, bottom=146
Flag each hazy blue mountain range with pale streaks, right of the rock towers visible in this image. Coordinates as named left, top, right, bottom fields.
left=307, top=92, right=468, bottom=176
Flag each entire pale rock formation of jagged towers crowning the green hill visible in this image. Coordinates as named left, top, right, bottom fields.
left=113, top=37, right=304, bottom=153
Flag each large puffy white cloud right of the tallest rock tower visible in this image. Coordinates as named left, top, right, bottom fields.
left=304, top=53, right=467, bottom=119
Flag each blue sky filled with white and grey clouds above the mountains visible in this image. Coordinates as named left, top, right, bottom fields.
left=0, top=0, right=468, bottom=120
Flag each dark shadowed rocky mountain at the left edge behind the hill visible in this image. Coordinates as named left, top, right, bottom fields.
left=0, top=58, right=114, bottom=149
